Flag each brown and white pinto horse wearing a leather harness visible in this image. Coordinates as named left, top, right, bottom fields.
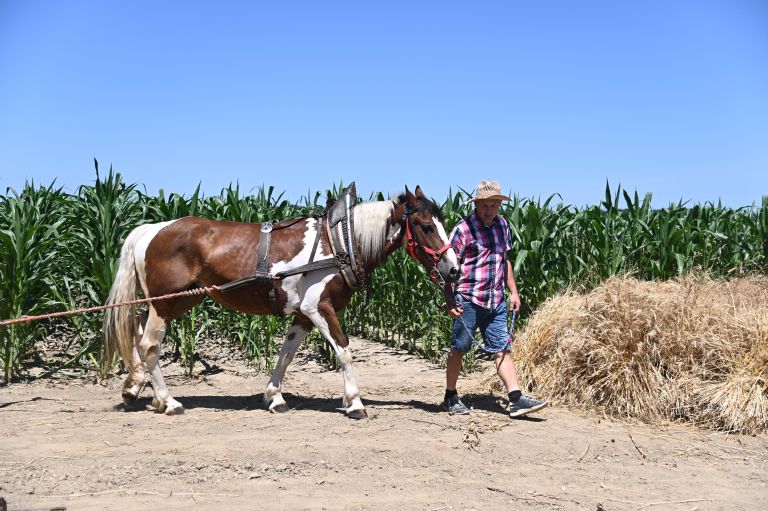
left=103, top=183, right=459, bottom=419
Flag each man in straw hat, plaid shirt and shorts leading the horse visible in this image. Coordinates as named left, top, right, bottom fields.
left=443, top=181, right=549, bottom=417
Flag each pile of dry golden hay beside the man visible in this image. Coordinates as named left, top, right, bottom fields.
left=513, top=276, right=768, bottom=434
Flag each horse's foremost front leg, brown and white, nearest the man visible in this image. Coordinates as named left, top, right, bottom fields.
left=301, top=298, right=368, bottom=419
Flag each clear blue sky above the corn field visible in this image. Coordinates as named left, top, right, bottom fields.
left=0, top=0, right=768, bottom=207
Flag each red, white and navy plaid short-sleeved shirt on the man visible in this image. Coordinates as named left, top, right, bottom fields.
left=450, top=211, right=512, bottom=309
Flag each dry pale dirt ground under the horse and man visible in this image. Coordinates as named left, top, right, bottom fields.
left=0, top=338, right=768, bottom=511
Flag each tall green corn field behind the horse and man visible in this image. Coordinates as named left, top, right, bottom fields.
left=0, top=162, right=768, bottom=383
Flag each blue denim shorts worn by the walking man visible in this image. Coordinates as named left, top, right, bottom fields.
left=451, top=293, right=511, bottom=353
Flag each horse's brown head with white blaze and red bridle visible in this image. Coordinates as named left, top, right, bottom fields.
left=403, top=186, right=459, bottom=284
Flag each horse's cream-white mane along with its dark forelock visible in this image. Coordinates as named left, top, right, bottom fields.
left=354, top=193, right=444, bottom=261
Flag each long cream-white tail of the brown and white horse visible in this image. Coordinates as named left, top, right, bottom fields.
left=102, top=224, right=152, bottom=371
